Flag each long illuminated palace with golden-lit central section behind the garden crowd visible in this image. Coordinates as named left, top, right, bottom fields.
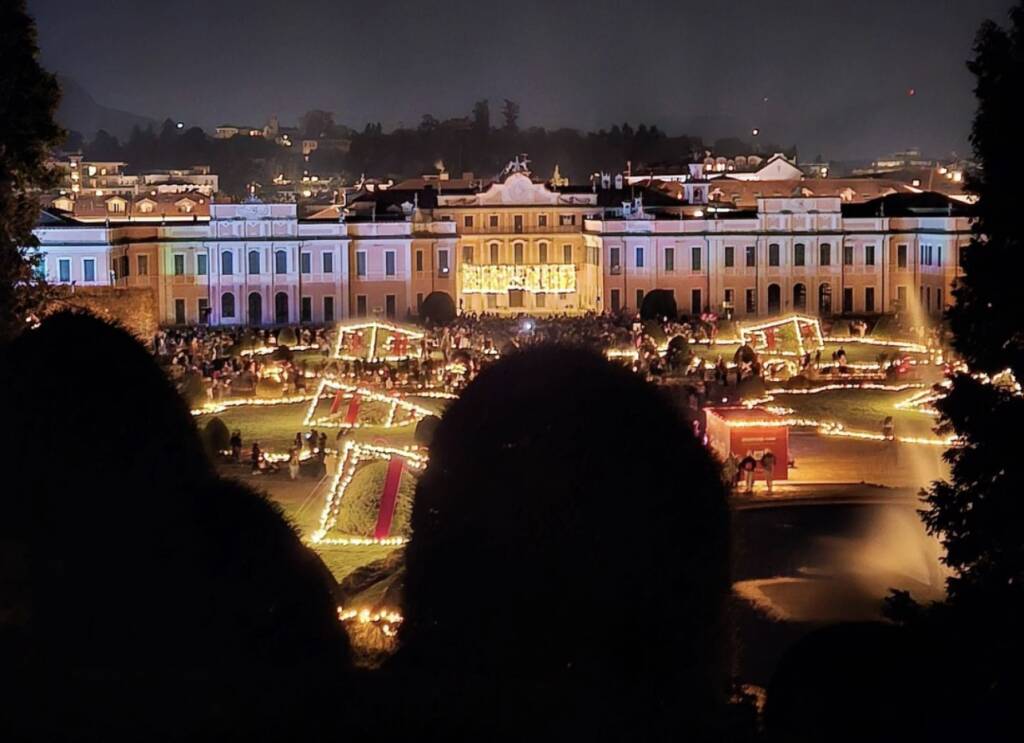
left=36, top=169, right=971, bottom=325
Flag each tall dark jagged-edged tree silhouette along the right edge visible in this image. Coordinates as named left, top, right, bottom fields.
left=892, top=3, right=1024, bottom=740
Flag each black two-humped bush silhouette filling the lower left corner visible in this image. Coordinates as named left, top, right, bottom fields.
left=0, top=313, right=349, bottom=740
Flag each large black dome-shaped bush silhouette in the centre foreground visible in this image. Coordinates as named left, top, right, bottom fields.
left=390, top=347, right=729, bottom=740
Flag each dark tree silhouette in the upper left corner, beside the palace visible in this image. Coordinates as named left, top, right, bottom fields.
left=0, top=0, right=63, bottom=342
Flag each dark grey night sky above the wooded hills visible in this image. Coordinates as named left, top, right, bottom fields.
left=29, top=0, right=1012, bottom=159
